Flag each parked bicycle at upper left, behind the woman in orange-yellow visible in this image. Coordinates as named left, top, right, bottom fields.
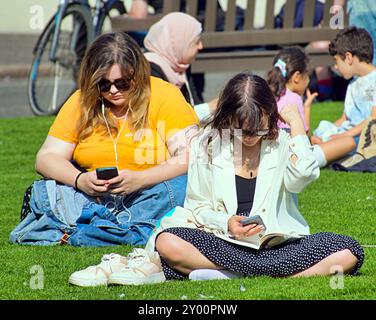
left=28, top=0, right=125, bottom=115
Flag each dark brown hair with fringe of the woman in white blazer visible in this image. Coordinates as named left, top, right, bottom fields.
left=205, top=73, right=280, bottom=140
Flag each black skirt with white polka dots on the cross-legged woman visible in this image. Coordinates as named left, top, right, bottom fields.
left=158, top=228, right=364, bottom=279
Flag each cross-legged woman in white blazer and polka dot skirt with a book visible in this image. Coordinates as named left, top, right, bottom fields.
left=154, top=73, right=364, bottom=279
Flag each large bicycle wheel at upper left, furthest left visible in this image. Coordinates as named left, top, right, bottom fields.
left=28, top=5, right=94, bottom=115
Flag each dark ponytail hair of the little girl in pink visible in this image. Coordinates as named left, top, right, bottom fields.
left=267, top=46, right=309, bottom=101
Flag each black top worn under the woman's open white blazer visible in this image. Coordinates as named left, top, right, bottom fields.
left=235, top=175, right=257, bottom=214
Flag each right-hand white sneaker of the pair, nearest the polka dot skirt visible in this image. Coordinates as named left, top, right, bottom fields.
left=108, top=249, right=166, bottom=285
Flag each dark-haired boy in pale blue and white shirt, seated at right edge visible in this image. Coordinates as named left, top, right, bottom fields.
left=312, top=27, right=376, bottom=150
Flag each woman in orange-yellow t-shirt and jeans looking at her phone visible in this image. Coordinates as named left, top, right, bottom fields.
left=11, top=33, right=198, bottom=245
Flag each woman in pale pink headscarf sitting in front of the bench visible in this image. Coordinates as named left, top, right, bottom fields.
left=144, top=12, right=216, bottom=120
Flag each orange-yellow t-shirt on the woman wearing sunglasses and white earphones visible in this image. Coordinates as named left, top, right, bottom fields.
left=49, top=77, right=198, bottom=171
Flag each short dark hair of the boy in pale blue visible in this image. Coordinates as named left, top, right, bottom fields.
left=329, top=27, right=374, bottom=64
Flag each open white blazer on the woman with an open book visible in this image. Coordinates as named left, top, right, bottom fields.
left=148, top=130, right=320, bottom=251
